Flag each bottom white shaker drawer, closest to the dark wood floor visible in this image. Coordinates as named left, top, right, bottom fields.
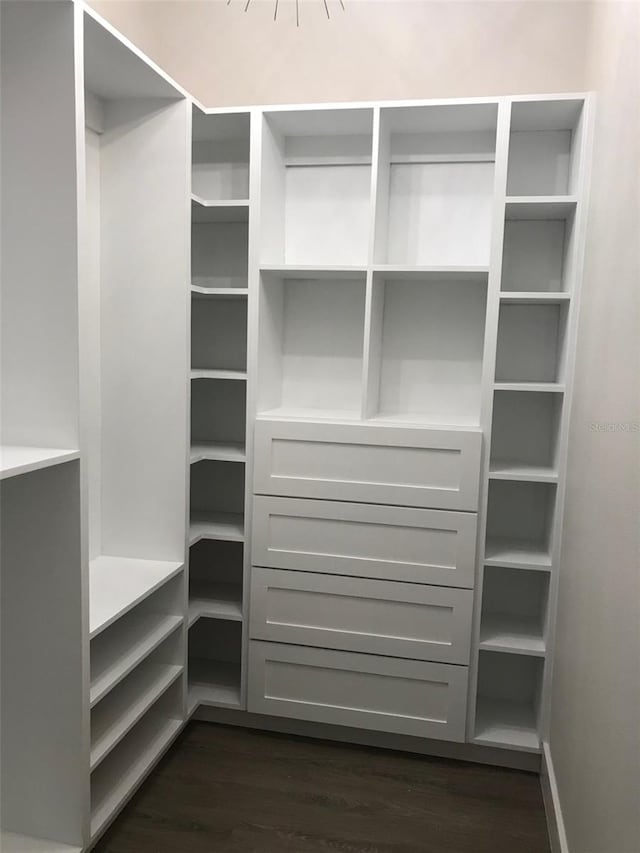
left=247, top=640, right=468, bottom=741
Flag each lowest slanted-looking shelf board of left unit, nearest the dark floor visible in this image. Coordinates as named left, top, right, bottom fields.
left=91, top=712, right=182, bottom=838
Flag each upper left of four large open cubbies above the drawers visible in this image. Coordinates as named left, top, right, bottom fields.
left=260, top=109, right=373, bottom=265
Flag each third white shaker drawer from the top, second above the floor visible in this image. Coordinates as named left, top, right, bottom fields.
left=250, top=568, right=473, bottom=664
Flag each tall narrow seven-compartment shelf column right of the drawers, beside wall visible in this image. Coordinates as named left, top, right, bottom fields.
left=470, top=97, right=589, bottom=752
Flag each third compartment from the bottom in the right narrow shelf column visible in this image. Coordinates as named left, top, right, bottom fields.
left=485, top=480, right=556, bottom=569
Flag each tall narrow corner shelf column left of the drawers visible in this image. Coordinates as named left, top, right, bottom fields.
left=187, top=106, right=251, bottom=713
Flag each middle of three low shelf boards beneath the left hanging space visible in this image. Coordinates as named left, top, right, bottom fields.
left=90, top=664, right=184, bottom=772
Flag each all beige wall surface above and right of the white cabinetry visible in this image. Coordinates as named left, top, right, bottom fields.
left=87, top=0, right=640, bottom=853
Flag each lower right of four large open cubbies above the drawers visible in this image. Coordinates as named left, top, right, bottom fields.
left=367, top=273, right=487, bottom=426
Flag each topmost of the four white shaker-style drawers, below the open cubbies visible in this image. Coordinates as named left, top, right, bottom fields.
left=254, top=420, right=482, bottom=511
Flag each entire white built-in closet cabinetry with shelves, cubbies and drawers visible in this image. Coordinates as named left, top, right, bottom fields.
left=0, top=0, right=591, bottom=853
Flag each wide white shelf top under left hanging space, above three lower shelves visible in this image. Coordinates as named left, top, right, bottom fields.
left=89, top=556, right=184, bottom=638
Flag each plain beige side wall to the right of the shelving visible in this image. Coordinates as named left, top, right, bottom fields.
left=550, top=2, right=640, bottom=853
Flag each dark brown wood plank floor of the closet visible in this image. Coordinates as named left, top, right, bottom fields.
left=95, top=723, right=549, bottom=853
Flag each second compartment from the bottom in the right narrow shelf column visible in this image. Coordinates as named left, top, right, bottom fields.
left=480, top=566, right=549, bottom=655
